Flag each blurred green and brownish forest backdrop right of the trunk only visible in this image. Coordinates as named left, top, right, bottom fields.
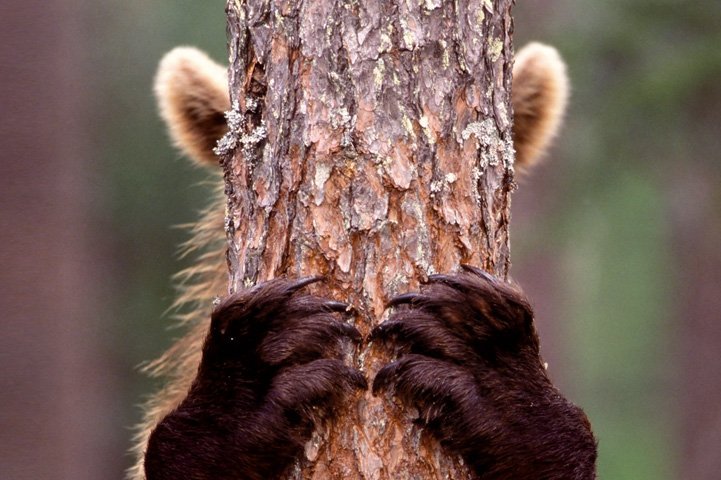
left=511, top=0, right=721, bottom=480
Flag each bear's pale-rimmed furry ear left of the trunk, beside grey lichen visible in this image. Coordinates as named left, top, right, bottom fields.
left=155, top=47, right=230, bottom=166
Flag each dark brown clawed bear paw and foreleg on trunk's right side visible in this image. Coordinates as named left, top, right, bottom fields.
left=370, top=266, right=596, bottom=480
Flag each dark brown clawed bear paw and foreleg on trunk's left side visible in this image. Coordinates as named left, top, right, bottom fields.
left=145, top=277, right=367, bottom=480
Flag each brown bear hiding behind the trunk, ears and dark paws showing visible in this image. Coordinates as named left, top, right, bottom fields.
left=130, top=43, right=597, bottom=480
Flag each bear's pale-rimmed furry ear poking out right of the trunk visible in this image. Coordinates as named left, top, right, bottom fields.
left=511, top=43, right=568, bottom=171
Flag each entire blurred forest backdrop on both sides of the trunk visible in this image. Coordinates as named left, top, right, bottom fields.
left=0, top=0, right=721, bottom=480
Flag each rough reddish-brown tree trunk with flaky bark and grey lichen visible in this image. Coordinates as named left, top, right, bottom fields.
left=218, top=0, right=514, bottom=479
